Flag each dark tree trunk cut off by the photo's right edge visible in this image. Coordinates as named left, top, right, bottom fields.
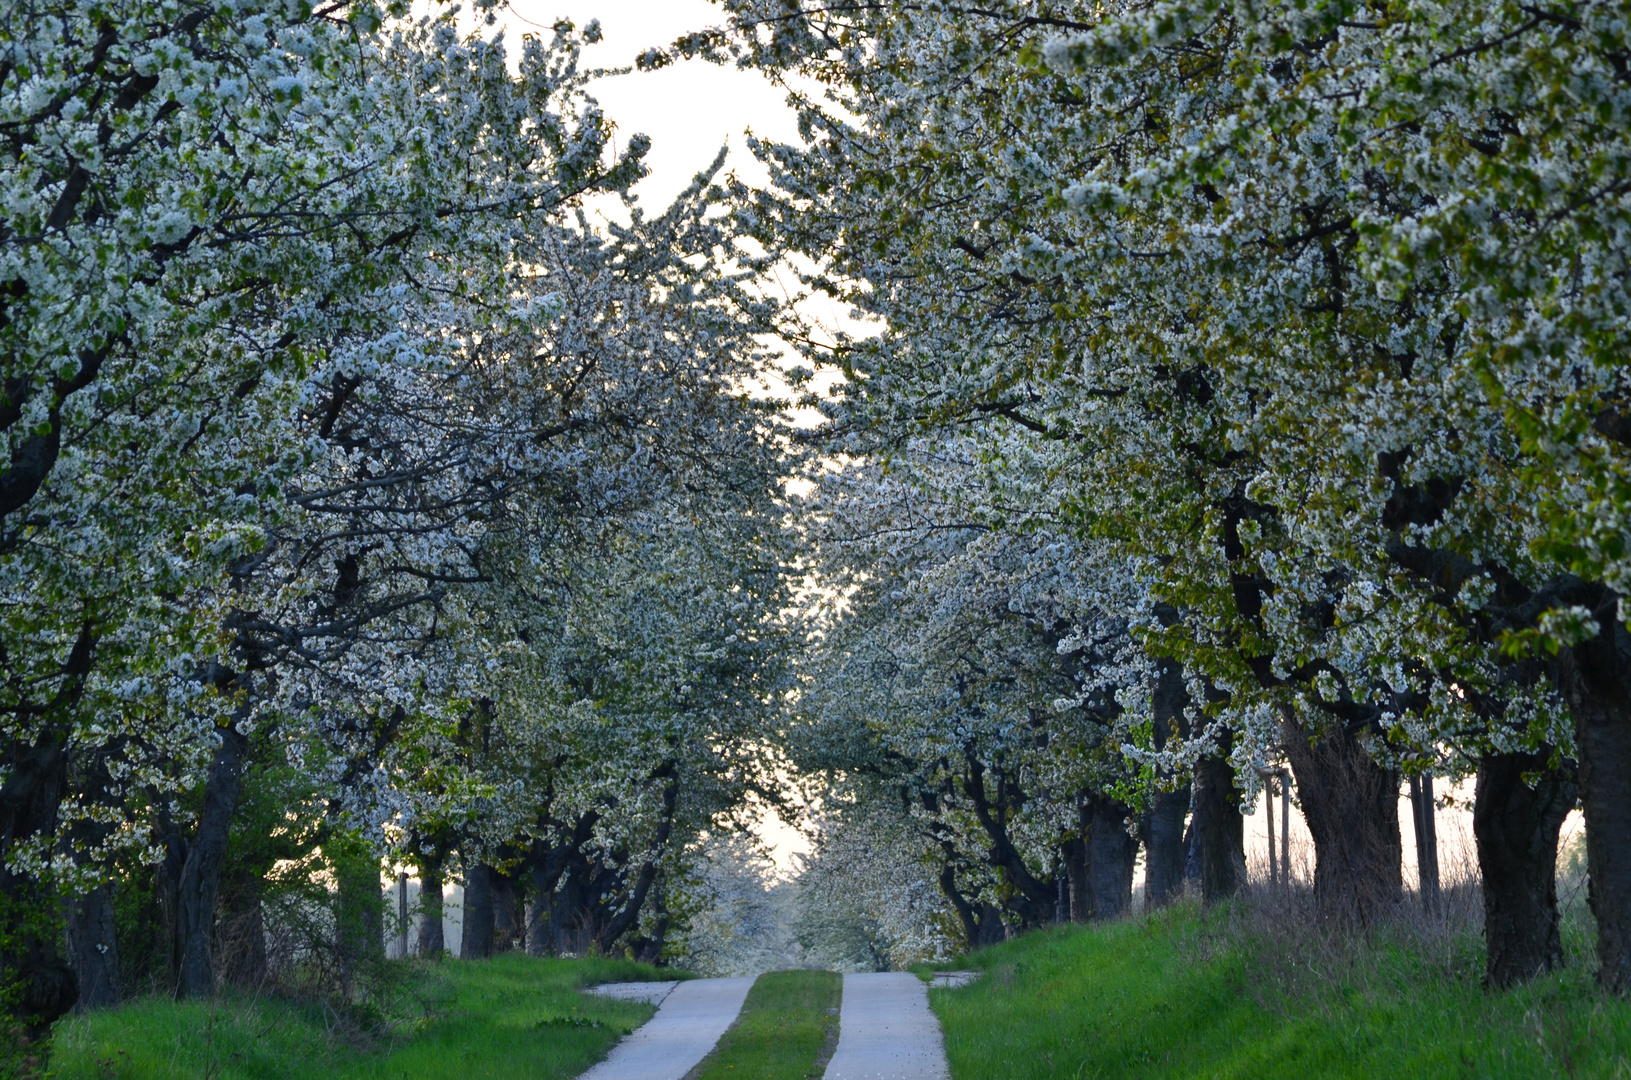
left=1558, top=603, right=1631, bottom=995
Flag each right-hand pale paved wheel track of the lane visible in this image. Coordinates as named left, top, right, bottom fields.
left=827, top=972, right=949, bottom=1080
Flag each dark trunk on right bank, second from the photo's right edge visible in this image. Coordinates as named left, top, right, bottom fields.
left=1473, top=754, right=1576, bottom=987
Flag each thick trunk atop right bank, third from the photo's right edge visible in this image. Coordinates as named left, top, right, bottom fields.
left=1285, top=721, right=1404, bottom=925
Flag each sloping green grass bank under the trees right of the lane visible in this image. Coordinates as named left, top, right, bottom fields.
left=930, top=905, right=1631, bottom=1080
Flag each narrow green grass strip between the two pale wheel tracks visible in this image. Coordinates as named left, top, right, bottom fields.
left=695, top=971, right=843, bottom=1080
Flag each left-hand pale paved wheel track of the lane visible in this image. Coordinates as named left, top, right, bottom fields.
left=579, top=979, right=754, bottom=1080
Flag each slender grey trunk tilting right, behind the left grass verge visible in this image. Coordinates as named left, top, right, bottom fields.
left=173, top=724, right=250, bottom=998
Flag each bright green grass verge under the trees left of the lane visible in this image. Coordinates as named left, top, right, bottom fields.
left=51, top=954, right=675, bottom=1080
